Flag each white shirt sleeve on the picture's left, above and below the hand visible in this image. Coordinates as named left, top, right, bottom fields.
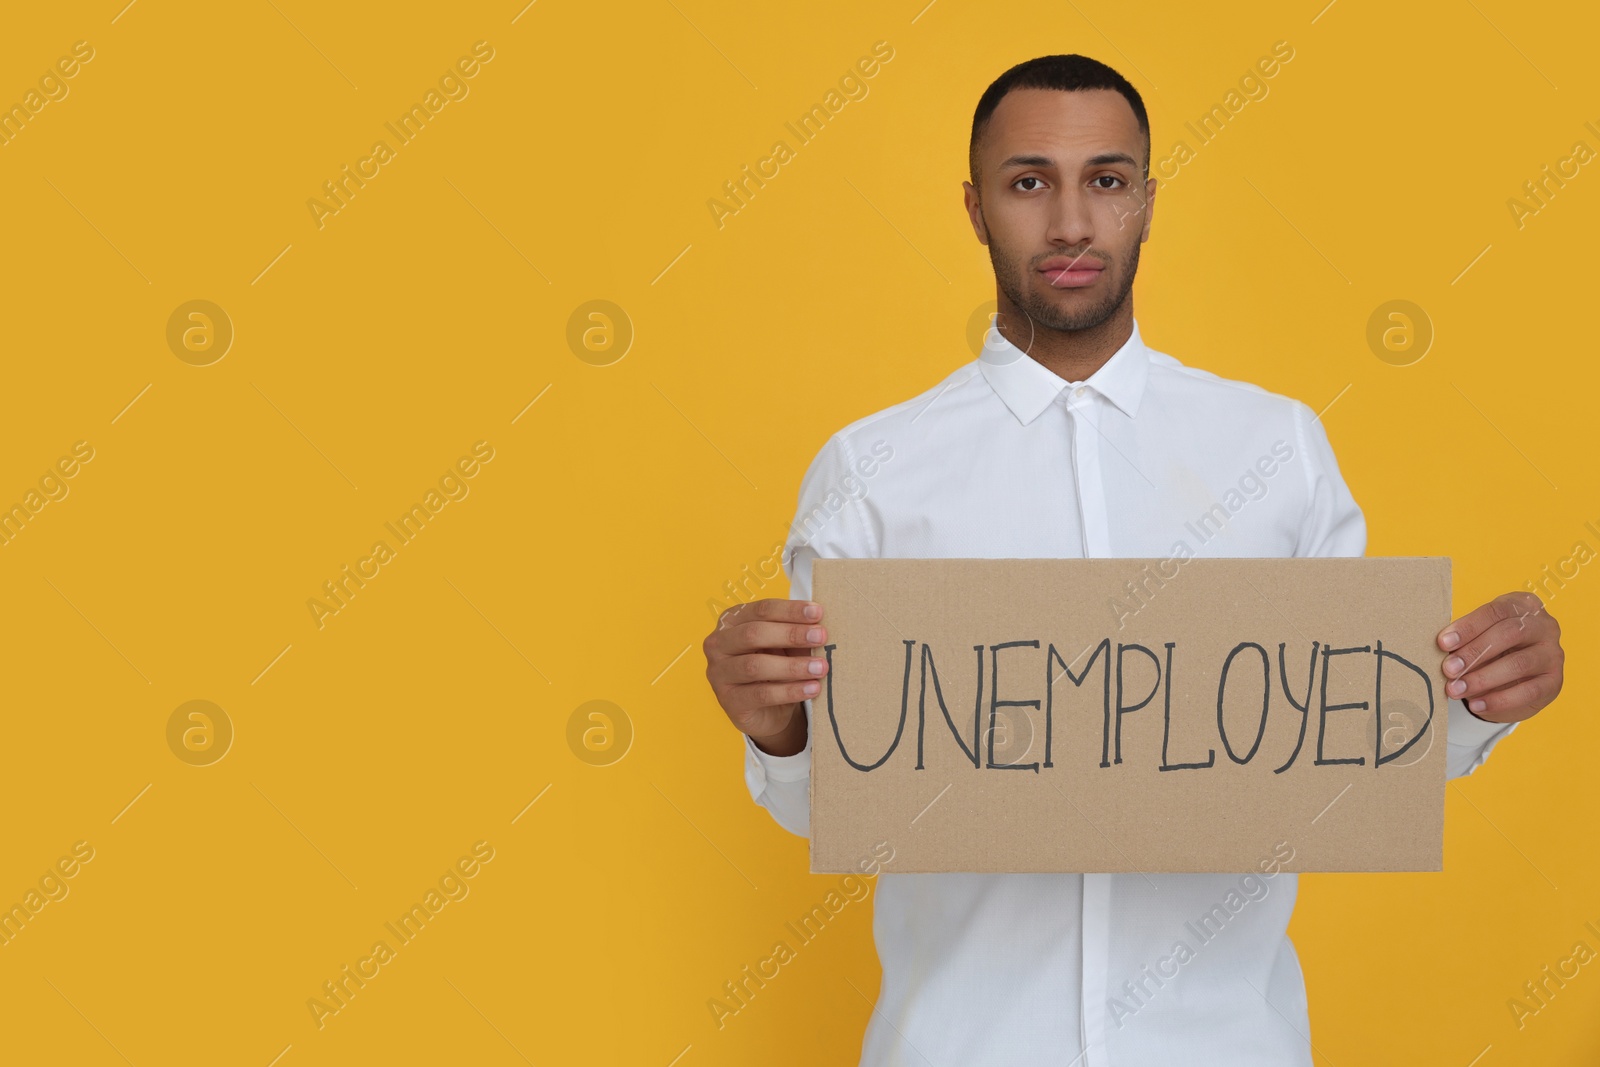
left=744, top=434, right=880, bottom=837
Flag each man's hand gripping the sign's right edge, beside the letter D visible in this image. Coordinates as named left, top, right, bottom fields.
left=1437, top=592, right=1566, bottom=723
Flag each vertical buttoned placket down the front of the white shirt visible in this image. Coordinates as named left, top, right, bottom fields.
left=1062, top=386, right=1112, bottom=1067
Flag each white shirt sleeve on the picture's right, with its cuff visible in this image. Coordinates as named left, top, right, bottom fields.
left=1294, top=403, right=1517, bottom=777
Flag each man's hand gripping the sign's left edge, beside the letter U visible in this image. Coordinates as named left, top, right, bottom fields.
left=702, top=598, right=827, bottom=755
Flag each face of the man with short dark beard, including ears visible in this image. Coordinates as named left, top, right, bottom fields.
left=962, top=90, right=1155, bottom=331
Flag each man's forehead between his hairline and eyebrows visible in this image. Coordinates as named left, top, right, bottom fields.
left=979, top=90, right=1144, bottom=171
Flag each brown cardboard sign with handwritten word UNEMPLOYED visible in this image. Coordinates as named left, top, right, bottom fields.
left=811, top=557, right=1451, bottom=873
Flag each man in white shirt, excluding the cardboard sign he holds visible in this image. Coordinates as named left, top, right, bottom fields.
left=704, top=56, right=1563, bottom=1067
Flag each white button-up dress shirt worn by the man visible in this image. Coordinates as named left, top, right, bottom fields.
left=744, top=316, right=1514, bottom=1067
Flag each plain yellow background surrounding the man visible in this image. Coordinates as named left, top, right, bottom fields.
left=0, top=0, right=1600, bottom=1067
